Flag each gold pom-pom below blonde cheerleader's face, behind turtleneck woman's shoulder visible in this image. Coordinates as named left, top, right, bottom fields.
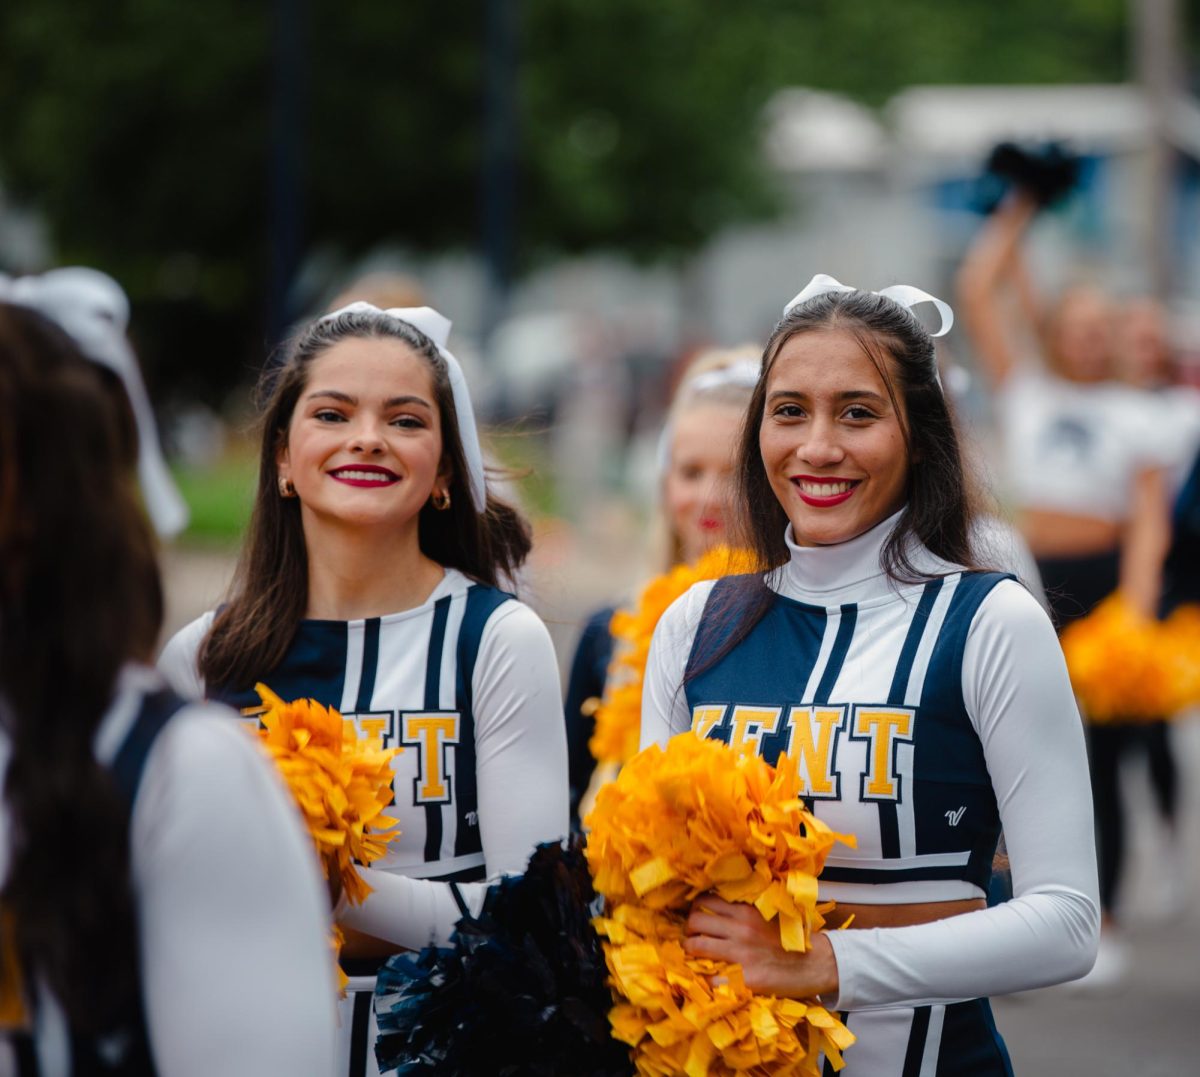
left=588, top=546, right=756, bottom=763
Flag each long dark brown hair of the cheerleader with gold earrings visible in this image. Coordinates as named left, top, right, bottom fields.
left=198, top=308, right=532, bottom=691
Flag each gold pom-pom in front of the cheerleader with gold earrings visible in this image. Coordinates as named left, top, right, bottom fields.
left=254, top=685, right=402, bottom=904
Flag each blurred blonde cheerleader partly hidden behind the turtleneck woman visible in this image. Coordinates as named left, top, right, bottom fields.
left=565, top=347, right=760, bottom=826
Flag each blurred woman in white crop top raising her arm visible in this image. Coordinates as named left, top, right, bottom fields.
left=959, top=188, right=1170, bottom=986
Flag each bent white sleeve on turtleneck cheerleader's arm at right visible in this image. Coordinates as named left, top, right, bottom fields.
left=829, top=583, right=1099, bottom=1010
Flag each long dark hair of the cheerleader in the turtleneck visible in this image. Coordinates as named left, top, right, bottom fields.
left=688, top=291, right=979, bottom=679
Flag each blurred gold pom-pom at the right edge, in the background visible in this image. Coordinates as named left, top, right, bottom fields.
left=1061, top=594, right=1200, bottom=723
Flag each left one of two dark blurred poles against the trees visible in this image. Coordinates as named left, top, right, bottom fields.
left=266, top=0, right=307, bottom=348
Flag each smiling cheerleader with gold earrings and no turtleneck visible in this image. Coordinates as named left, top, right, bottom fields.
left=160, top=302, right=568, bottom=1077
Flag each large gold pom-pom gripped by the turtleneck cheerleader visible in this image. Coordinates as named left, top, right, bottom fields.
left=584, top=733, right=854, bottom=1077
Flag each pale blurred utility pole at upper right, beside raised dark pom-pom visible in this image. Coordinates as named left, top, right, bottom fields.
left=1129, top=0, right=1183, bottom=300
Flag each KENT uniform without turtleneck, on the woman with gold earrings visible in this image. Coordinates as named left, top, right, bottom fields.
left=160, top=568, right=568, bottom=1077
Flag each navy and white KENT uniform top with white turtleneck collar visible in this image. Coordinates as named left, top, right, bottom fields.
left=642, top=517, right=1099, bottom=1010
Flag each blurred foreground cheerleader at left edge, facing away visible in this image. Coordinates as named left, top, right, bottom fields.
left=0, top=280, right=336, bottom=1077
